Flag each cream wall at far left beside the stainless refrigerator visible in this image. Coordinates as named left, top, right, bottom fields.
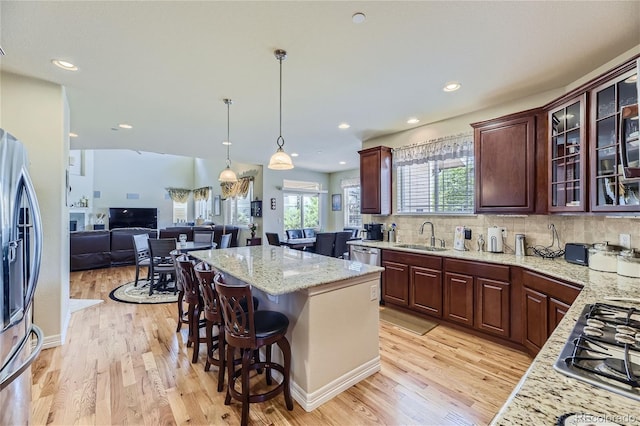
left=0, top=73, right=70, bottom=347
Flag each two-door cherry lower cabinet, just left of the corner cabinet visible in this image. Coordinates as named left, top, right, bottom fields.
left=444, top=259, right=511, bottom=339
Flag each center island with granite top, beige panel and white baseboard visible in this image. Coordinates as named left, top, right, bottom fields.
left=189, top=246, right=384, bottom=411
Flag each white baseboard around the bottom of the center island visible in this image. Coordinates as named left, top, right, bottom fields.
left=291, top=356, right=380, bottom=411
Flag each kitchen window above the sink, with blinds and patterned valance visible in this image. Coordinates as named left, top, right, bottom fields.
left=393, top=135, right=474, bottom=214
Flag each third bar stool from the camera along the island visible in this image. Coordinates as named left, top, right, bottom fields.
left=175, top=253, right=206, bottom=363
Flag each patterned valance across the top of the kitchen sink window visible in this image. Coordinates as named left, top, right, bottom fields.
left=392, top=133, right=473, bottom=167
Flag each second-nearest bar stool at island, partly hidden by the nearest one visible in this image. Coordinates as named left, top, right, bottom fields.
left=194, top=262, right=225, bottom=392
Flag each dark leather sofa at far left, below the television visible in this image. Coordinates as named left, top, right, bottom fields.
left=69, top=228, right=158, bottom=271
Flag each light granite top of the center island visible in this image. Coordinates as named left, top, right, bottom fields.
left=189, top=245, right=384, bottom=296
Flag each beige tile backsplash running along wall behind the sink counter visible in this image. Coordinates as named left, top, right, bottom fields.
left=363, top=215, right=640, bottom=253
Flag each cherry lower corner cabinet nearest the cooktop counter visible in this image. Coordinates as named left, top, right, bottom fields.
left=522, top=270, right=581, bottom=354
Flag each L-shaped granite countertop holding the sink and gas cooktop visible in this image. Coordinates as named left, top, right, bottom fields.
left=352, top=241, right=640, bottom=425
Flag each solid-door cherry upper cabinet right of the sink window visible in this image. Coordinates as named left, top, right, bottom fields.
left=471, top=109, right=547, bottom=214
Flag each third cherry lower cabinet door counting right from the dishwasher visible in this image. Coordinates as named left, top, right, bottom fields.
left=444, top=272, right=473, bottom=327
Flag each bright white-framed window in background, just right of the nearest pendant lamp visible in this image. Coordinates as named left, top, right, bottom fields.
left=283, top=180, right=321, bottom=229
